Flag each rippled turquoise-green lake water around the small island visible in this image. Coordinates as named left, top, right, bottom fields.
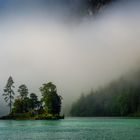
left=0, top=118, right=140, bottom=140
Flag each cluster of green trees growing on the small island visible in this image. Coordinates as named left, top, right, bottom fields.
left=3, top=76, right=62, bottom=118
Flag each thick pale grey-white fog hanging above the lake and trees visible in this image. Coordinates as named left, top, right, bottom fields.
left=0, top=1, right=140, bottom=113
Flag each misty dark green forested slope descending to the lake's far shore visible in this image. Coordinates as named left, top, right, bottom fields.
left=70, top=72, right=140, bottom=117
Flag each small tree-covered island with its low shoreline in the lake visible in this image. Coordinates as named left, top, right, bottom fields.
left=0, top=76, right=64, bottom=120
